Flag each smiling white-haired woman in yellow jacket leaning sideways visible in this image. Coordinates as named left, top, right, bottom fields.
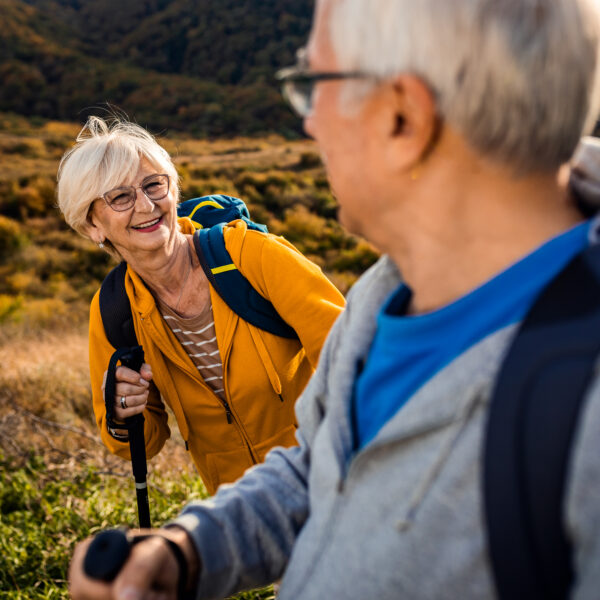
left=58, top=117, right=344, bottom=493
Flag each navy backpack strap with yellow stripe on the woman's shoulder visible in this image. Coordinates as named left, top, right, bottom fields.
left=194, top=223, right=298, bottom=339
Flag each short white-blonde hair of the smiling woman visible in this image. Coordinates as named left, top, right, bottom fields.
left=57, top=117, right=179, bottom=237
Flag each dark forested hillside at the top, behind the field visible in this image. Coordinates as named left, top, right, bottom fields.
left=0, top=0, right=313, bottom=137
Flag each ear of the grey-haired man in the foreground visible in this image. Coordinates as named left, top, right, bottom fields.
left=380, top=75, right=439, bottom=171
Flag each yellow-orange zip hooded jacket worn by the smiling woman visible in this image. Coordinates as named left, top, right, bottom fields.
left=89, top=218, right=344, bottom=494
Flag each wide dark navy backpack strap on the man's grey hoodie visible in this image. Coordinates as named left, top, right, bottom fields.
left=483, top=241, right=600, bottom=600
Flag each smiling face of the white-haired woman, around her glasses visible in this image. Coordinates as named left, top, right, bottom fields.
left=88, top=160, right=177, bottom=262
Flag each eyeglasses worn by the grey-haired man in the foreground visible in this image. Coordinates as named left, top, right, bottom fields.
left=275, top=48, right=377, bottom=119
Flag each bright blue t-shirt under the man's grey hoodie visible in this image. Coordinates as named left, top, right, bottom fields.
left=353, top=221, right=590, bottom=448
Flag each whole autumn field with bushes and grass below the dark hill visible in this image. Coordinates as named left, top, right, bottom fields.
left=0, top=114, right=376, bottom=599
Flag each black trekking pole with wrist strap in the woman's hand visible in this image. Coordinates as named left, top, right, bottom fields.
left=104, top=346, right=151, bottom=527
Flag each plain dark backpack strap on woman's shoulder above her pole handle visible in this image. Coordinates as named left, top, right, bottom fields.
left=100, top=262, right=138, bottom=349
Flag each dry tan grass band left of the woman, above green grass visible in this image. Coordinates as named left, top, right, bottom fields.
left=0, top=327, right=194, bottom=481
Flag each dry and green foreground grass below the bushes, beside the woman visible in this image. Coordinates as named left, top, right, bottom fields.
left=0, top=325, right=219, bottom=598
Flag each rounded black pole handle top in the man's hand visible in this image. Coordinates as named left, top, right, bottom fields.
left=83, top=529, right=131, bottom=582
